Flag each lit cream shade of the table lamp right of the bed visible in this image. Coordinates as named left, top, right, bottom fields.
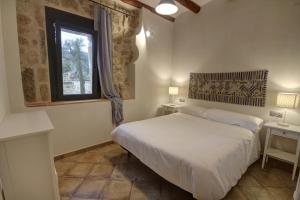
left=277, top=92, right=298, bottom=108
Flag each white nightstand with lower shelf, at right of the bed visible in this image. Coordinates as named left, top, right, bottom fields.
left=262, top=122, right=300, bottom=180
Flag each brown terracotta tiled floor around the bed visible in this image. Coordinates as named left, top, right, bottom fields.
left=55, top=144, right=296, bottom=200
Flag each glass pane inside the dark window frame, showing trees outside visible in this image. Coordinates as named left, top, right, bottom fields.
left=61, top=28, right=93, bottom=95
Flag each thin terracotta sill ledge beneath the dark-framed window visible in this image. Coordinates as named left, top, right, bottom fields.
left=25, top=98, right=134, bottom=108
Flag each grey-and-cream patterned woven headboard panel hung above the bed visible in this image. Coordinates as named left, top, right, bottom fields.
left=189, top=70, right=268, bottom=107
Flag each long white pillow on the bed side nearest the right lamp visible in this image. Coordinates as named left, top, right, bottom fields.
left=203, top=109, right=263, bottom=133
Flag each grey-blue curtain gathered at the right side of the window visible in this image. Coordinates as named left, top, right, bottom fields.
left=94, top=6, right=123, bottom=126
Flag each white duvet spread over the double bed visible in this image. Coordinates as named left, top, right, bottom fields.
left=112, top=113, right=260, bottom=200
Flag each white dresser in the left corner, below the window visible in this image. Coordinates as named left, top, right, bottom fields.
left=0, top=111, right=59, bottom=200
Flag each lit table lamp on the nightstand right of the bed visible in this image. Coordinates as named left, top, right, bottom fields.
left=277, top=92, right=299, bottom=126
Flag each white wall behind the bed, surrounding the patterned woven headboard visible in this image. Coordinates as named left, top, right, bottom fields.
left=172, top=0, right=300, bottom=152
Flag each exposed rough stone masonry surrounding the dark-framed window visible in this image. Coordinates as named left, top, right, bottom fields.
left=16, top=0, right=140, bottom=106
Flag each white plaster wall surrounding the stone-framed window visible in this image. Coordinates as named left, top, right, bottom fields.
left=3, top=0, right=173, bottom=155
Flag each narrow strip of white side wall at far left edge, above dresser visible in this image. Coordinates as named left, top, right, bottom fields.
left=0, top=2, right=9, bottom=122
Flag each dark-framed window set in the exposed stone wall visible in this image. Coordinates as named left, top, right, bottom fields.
left=46, top=7, right=100, bottom=101
